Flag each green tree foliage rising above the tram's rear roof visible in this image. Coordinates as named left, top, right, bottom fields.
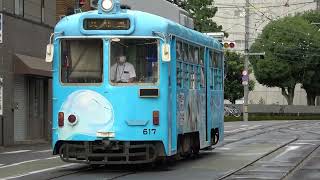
left=178, top=0, right=222, bottom=32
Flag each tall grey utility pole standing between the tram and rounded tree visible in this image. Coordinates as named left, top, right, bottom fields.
left=243, top=0, right=250, bottom=121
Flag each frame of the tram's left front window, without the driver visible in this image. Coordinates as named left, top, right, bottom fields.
left=59, top=38, right=105, bottom=86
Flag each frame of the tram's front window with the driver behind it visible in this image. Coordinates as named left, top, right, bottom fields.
left=108, top=37, right=161, bottom=86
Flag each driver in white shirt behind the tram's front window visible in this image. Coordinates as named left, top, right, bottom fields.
left=110, top=55, right=136, bottom=83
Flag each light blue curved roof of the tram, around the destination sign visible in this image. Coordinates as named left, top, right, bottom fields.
left=55, top=10, right=222, bottom=49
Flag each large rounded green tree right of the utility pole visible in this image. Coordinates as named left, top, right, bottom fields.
left=250, top=16, right=319, bottom=105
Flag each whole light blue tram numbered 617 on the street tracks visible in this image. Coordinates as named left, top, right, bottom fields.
left=46, top=0, right=224, bottom=164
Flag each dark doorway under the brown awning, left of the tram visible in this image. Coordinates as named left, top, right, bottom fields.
left=28, top=78, right=48, bottom=140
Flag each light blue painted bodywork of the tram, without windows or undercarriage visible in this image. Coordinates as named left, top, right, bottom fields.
left=52, top=7, right=223, bottom=155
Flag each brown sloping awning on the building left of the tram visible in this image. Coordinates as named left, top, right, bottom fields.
left=14, top=54, right=52, bottom=77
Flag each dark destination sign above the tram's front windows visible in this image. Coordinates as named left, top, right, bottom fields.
left=83, top=18, right=130, bottom=30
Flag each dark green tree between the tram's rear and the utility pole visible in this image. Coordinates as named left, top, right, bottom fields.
left=224, top=51, right=254, bottom=104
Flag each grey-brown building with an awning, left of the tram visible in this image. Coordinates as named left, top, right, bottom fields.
left=0, top=0, right=56, bottom=146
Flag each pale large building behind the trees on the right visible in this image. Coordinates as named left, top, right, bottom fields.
left=214, top=0, right=319, bottom=105
